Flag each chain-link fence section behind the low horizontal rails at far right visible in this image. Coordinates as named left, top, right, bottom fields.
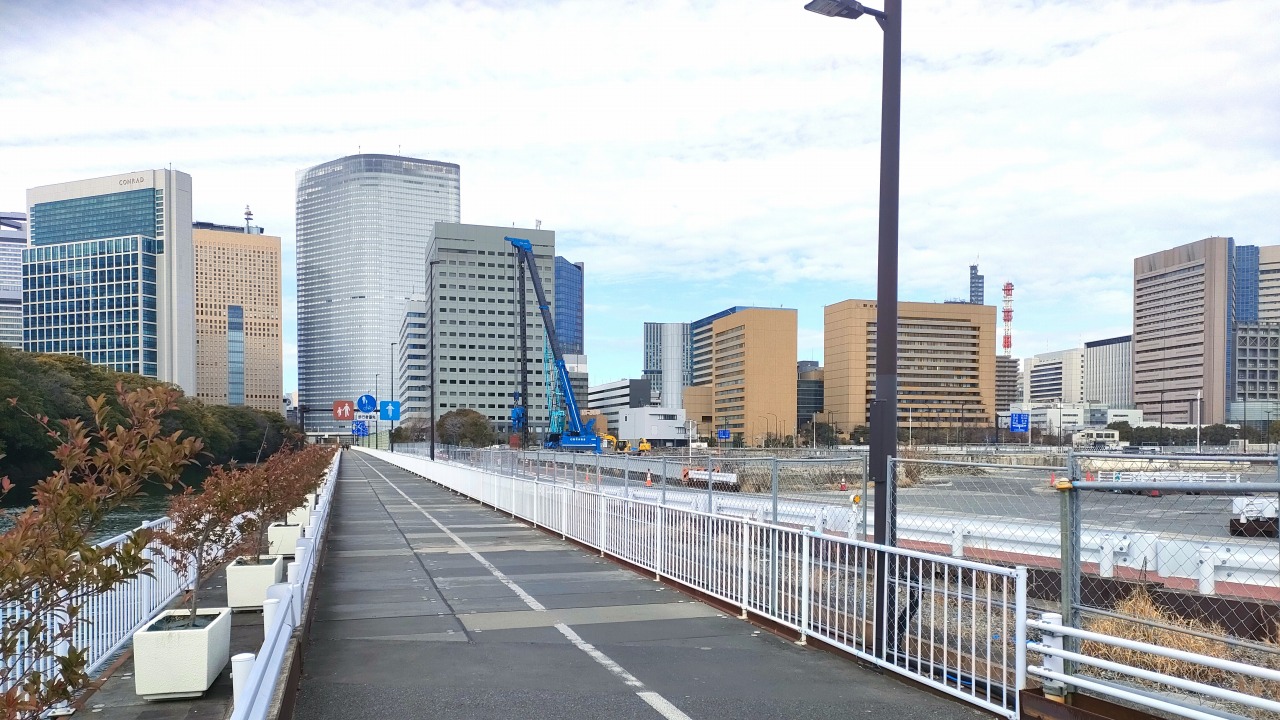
left=1062, top=454, right=1280, bottom=717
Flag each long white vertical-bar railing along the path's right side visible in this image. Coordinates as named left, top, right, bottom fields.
left=358, top=448, right=1027, bottom=717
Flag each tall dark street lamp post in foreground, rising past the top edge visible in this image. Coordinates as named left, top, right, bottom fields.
left=805, top=0, right=902, bottom=657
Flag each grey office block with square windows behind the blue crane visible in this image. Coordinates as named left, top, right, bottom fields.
left=428, top=223, right=552, bottom=434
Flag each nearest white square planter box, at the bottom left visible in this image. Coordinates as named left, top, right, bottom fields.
left=133, top=607, right=232, bottom=700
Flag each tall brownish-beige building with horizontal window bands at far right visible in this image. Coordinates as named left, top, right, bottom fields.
left=1133, top=237, right=1233, bottom=424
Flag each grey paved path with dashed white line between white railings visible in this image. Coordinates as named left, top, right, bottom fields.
left=294, top=452, right=986, bottom=720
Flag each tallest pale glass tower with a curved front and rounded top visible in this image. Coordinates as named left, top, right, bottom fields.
left=297, top=155, right=460, bottom=432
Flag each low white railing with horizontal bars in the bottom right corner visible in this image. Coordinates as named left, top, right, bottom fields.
left=1027, top=612, right=1280, bottom=720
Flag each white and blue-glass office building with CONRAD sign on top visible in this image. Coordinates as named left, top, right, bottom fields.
left=22, top=170, right=196, bottom=396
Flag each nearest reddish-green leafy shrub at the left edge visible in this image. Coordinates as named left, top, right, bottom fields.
left=0, top=384, right=202, bottom=719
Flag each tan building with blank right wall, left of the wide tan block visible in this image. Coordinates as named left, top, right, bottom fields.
left=684, top=307, right=799, bottom=445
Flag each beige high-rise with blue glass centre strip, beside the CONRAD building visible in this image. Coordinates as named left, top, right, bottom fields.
left=192, top=223, right=284, bottom=413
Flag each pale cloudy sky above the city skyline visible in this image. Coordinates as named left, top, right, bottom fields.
left=0, top=0, right=1280, bottom=391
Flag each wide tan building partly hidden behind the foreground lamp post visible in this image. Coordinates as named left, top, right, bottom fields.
left=823, top=300, right=996, bottom=428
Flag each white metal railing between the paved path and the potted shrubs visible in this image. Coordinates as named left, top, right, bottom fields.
left=230, top=454, right=342, bottom=720
